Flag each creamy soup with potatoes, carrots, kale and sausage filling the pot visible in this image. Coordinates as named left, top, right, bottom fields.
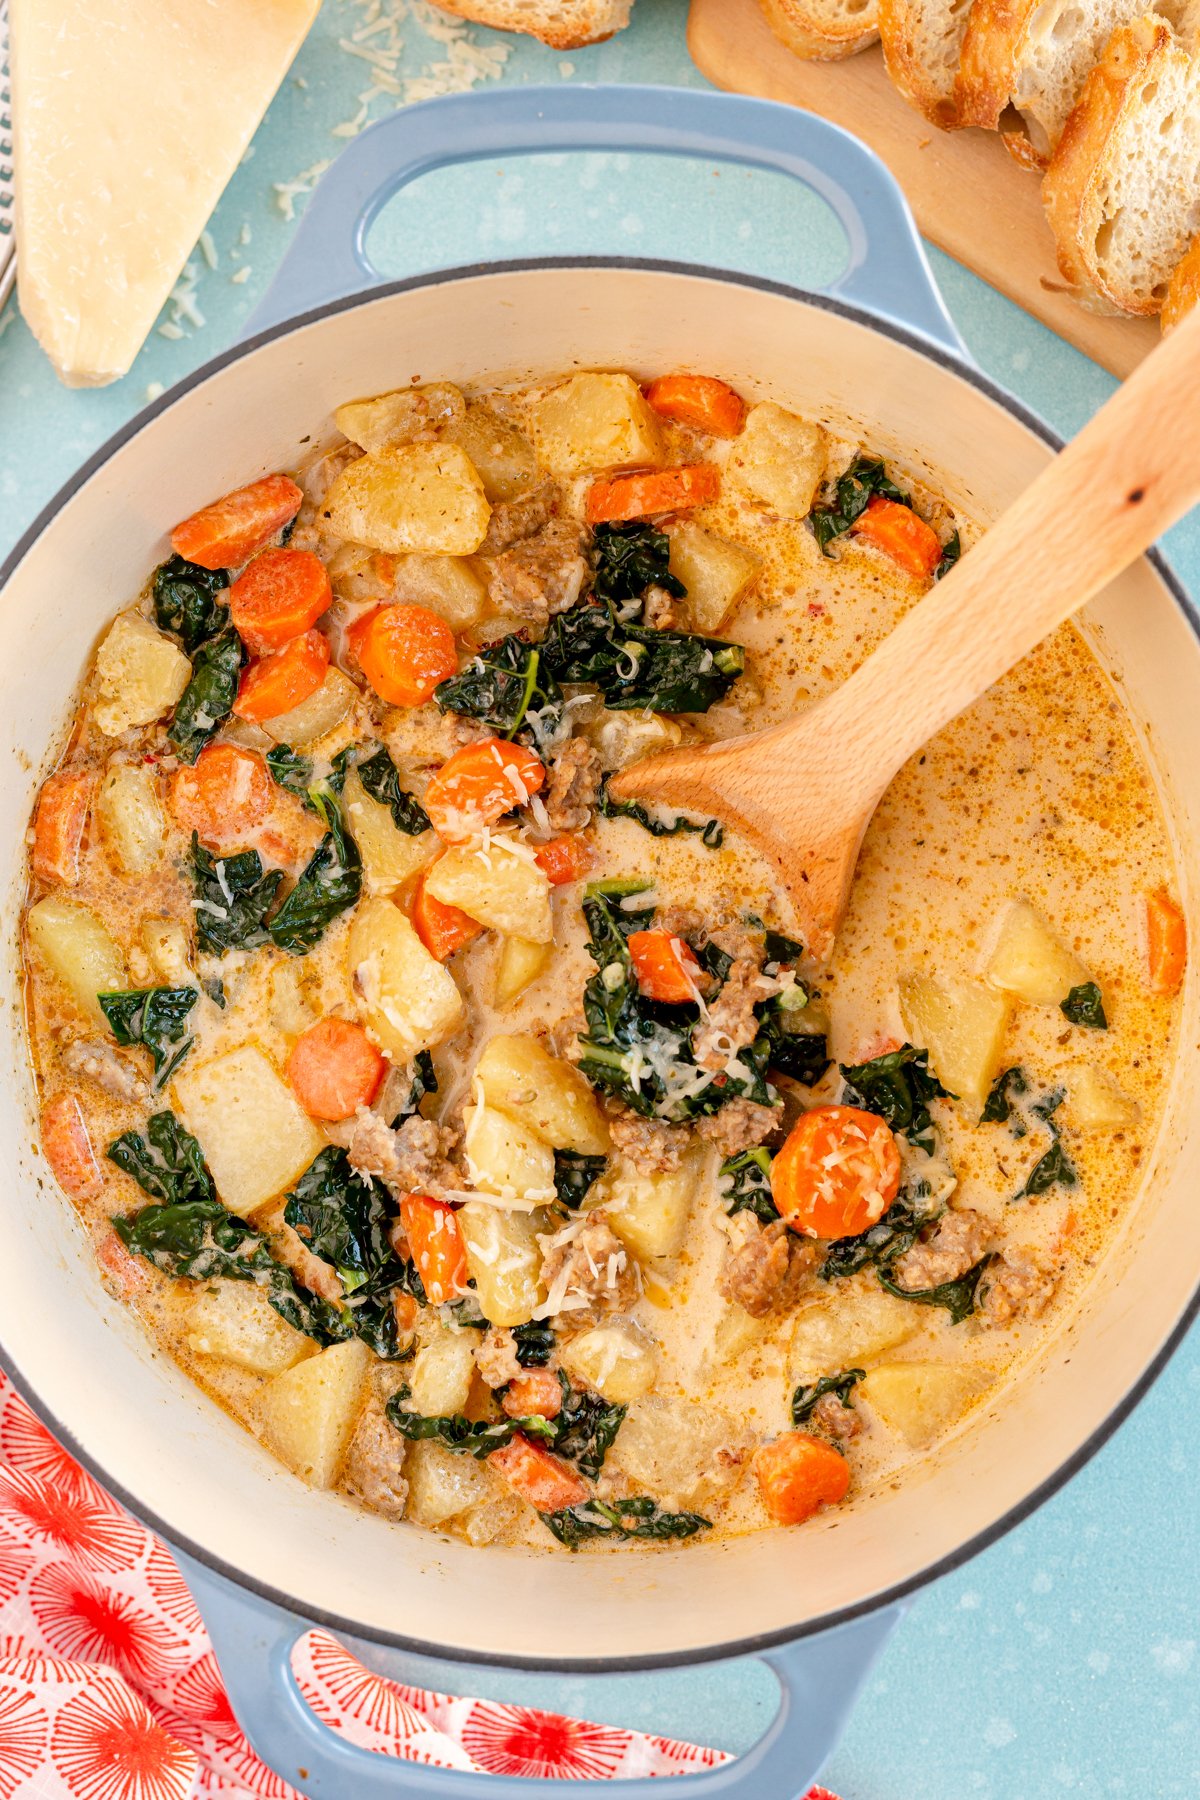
left=25, top=373, right=1186, bottom=1550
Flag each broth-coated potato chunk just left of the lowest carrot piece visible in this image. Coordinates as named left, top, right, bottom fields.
left=606, top=1395, right=748, bottom=1507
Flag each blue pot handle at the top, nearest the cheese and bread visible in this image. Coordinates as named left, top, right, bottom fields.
left=246, top=85, right=966, bottom=358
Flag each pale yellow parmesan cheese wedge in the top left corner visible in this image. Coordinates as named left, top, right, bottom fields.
left=11, top=0, right=320, bottom=387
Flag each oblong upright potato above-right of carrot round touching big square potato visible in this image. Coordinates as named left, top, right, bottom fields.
left=349, top=900, right=462, bottom=1062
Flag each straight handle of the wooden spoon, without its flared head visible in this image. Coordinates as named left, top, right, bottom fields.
left=813, top=308, right=1200, bottom=806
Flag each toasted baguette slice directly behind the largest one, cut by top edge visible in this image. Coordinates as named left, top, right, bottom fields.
left=957, top=0, right=1195, bottom=169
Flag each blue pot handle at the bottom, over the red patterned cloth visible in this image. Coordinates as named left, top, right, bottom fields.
left=175, top=1550, right=905, bottom=1800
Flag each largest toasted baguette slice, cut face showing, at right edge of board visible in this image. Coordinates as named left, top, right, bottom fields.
left=1042, top=13, right=1200, bottom=313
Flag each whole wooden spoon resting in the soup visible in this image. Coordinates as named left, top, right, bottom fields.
left=610, top=308, right=1200, bottom=956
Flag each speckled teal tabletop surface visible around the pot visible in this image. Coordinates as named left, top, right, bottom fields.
left=0, top=0, right=1200, bottom=1800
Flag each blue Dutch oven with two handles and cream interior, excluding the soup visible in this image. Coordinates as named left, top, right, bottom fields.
left=0, top=88, right=1200, bottom=1800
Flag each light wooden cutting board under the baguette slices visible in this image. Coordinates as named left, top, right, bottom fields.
left=687, top=0, right=1159, bottom=376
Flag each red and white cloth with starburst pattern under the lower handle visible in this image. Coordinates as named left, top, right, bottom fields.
left=0, top=1375, right=835, bottom=1800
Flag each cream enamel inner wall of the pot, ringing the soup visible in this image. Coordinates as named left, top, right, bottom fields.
left=0, top=265, right=1200, bottom=1669
